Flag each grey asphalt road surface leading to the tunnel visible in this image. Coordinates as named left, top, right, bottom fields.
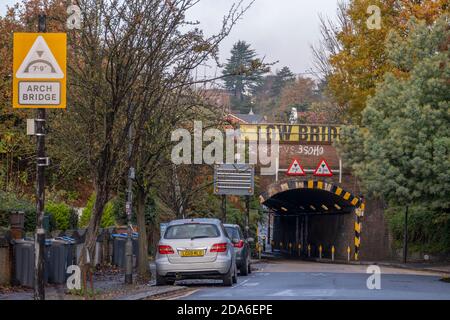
left=173, top=260, right=450, bottom=300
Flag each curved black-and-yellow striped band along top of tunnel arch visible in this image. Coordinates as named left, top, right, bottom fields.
left=259, top=180, right=362, bottom=207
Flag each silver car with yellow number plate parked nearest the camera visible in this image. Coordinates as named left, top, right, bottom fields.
left=155, top=219, right=237, bottom=286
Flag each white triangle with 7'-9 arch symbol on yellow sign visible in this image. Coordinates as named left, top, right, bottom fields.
left=16, top=36, right=64, bottom=79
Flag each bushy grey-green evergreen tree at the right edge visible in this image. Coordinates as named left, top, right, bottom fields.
left=341, top=17, right=450, bottom=250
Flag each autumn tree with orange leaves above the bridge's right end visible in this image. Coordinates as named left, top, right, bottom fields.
left=314, top=0, right=448, bottom=122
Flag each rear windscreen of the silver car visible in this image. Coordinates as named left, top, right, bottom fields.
left=164, top=223, right=220, bottom=239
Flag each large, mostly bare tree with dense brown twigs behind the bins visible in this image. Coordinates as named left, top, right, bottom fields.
left=53, top=0, right=253, bottom=280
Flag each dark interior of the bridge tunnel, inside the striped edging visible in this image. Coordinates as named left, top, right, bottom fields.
left=263, top=189, right=355, bottom=258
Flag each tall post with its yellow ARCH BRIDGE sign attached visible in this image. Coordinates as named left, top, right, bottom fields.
left=12, top=14, right=67, bottom=300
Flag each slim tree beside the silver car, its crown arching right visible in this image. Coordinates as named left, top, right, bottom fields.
left=135, top=86, right=220, bottom=280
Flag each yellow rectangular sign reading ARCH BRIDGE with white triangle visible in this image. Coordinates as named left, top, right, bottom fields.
left=13, top=33, right=67, bottom=108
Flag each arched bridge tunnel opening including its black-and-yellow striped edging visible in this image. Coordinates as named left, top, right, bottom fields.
left=260, top=180, right=364, bottom=260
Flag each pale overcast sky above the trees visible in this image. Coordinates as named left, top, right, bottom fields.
left=0, top=0, right=337, bottom=77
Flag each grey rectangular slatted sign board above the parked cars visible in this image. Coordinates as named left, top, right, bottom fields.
left=214, top=164, right=255, bottom=196
